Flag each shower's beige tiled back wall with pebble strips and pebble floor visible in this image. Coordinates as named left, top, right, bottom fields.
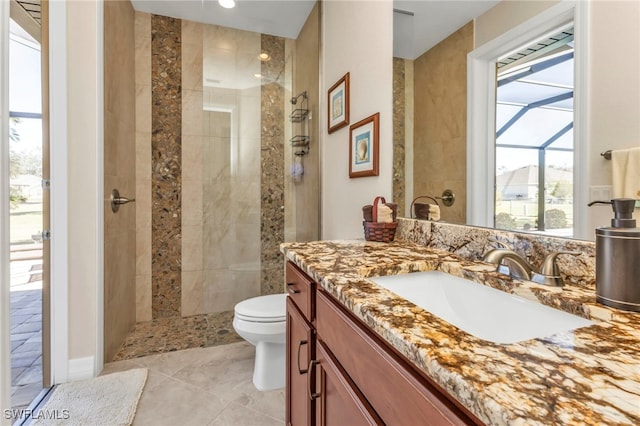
left=105, top=2, right=308, bottom=362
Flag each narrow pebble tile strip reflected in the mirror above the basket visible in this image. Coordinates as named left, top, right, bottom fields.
left=393, top=58, right=406, bottom=216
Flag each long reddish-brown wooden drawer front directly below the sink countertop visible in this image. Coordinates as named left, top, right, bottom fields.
left=316, top=291, right=476, bottom=425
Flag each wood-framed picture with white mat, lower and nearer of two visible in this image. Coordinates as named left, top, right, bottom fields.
left=349, top=112, right=380, bottom=178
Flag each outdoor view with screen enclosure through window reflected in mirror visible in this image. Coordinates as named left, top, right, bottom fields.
left=495, top=27, right=574, bottom=237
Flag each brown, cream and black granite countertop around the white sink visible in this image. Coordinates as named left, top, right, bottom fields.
left=281, top=241, right=640, bottom=425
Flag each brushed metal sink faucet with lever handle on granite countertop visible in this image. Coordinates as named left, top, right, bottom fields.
left=482, top=248, right=580, bottom=287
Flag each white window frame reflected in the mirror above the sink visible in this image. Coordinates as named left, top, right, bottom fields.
left=467, top=1, right=589, bottom=238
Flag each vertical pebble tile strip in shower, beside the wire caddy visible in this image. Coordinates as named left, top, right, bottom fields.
left=260, top=34, right=285, bottom=294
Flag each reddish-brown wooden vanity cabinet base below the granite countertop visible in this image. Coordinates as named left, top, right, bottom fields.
left=286, top=262, right=481, bottom=425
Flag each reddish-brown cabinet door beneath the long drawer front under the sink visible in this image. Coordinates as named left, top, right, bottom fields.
left=312, top=342, right=384, bottom=426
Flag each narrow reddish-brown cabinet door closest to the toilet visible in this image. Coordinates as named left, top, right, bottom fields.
left=285, top=298, right=315, bottom=426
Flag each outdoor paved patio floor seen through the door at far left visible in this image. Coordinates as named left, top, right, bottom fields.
left=10, top=246, right=42, bottom=409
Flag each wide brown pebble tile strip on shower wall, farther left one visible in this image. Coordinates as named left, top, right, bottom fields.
left=151, top=15, right=182, bottom=319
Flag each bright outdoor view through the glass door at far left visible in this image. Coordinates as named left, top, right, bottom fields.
left=9, top=20, right=44, bottom=412
